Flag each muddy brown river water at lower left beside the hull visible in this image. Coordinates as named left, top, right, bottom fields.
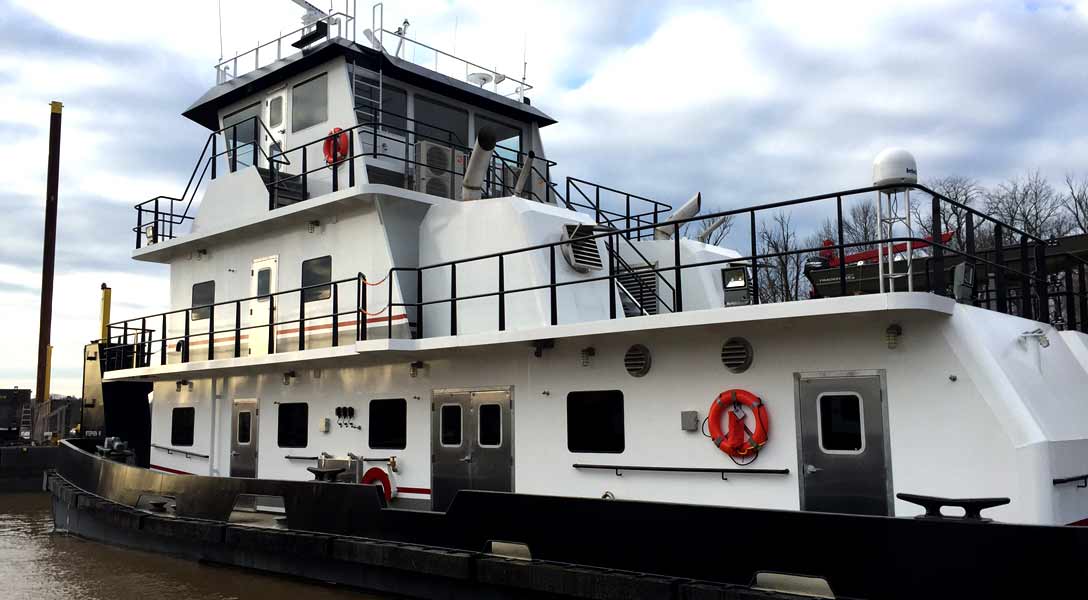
left=0, top=493, right=390, bottom=600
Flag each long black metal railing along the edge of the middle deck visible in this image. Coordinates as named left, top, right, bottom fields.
left=107, top=185, right=1088, bottom=368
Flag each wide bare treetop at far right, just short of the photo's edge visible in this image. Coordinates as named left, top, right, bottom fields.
left=986, top=170, right=1076, bottom=238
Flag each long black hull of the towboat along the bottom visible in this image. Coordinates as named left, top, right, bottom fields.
left=49, top=446, right=1088, bottom=599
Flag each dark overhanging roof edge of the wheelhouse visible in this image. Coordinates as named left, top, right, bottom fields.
left=182, top=38, right=556, bottom=131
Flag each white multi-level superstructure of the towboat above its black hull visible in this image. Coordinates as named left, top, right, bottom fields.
left=87, top=1, right=1088, bottom=525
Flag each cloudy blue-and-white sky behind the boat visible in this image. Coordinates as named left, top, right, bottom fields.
left=0, top=0, right=1088, bottom=393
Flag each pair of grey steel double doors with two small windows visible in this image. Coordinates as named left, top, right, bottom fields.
left=431, top=388, right=514, bottom=511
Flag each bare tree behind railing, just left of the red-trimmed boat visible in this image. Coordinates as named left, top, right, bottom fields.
left=757, top=211, right=807, bottom=302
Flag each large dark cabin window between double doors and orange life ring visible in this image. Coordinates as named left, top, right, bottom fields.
left=567, top=390, right=623, bottom=454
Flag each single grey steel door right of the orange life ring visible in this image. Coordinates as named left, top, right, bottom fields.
left=794, top=371, right=892, bottom=515
